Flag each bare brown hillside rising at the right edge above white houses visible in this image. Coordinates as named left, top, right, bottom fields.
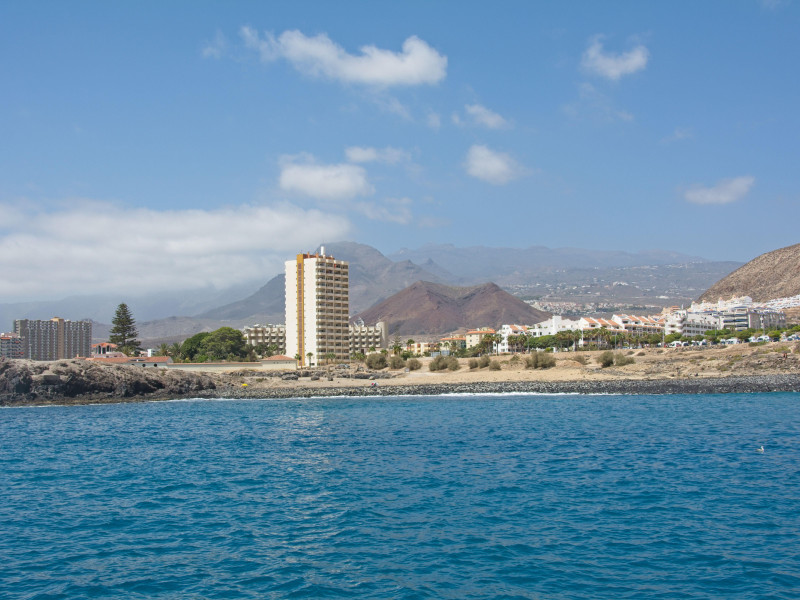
left=700, top=244, right=800, bottom=302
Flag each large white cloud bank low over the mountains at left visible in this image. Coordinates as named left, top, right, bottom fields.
left=0, top=200, right=351, bottom=302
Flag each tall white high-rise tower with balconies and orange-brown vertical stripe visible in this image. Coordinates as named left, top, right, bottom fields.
left=286, top=246, right=350, bottom=366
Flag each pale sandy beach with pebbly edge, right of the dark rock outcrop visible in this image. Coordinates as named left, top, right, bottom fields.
left=212, top=342, right=800, bottom=397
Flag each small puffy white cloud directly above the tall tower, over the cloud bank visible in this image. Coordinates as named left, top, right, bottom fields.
left=279, top=157, right=374, bottom=200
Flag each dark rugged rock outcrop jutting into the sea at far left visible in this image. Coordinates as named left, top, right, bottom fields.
left=0, top=358, right=217, bottom=406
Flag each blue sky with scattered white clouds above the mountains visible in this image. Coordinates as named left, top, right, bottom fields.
left=0, top=0, right=800, bottom=301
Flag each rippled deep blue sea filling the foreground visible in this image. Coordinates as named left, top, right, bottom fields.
left=0, top=394, right=800, bottom=600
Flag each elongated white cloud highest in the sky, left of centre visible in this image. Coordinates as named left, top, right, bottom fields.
left=241, top=27, right=447, bottom=87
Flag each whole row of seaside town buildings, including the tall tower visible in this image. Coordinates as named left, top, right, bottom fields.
left=0, top=247, right=800, bottom=369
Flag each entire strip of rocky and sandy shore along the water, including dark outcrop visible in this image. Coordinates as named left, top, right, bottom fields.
left=0, top=359, right=800, bottom=406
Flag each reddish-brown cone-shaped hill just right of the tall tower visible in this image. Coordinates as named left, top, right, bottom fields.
left=354, top=281, right=550, bottom=335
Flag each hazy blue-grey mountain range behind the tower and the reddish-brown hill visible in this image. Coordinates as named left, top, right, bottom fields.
left=0, top=242, right=741, bottom=344
